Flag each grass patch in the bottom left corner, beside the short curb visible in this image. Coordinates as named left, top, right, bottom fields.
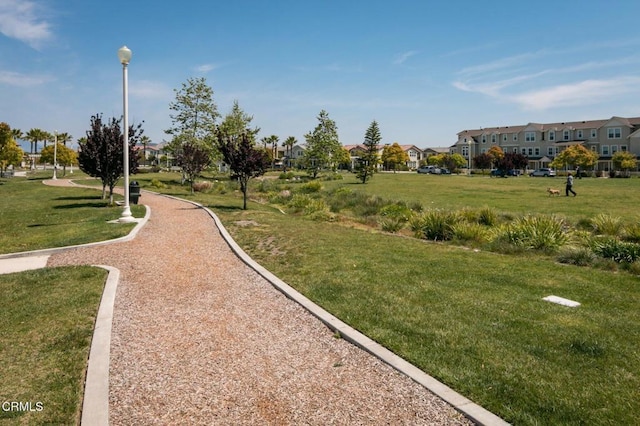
left=0, top=266, right=107, bottom=425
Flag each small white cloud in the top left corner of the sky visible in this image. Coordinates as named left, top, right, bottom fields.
left=0, top=0, right=52, bottom=49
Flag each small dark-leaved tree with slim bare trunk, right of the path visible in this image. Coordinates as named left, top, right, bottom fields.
left=217, top=133, right=269, bottom=210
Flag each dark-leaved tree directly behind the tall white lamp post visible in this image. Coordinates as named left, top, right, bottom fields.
left=78, top=114, right=143, bottom=204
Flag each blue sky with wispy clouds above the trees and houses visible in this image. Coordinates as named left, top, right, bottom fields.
left=0, top=0, right=640, bottom=148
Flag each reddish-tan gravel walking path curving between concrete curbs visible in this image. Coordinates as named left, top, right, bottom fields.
left=49, top=181, right=470, bottom=425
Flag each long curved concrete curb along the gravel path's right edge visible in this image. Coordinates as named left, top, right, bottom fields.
left=166, top=194, right=509, bottom=426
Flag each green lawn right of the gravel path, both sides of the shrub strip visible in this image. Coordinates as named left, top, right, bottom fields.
left=130, top=174, right=640, bottom=425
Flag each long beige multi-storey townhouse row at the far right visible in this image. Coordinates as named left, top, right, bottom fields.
left=451, top=117, right=640, bottom=171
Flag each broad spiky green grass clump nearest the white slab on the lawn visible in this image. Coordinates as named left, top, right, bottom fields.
left=499, top=215, right=569, bottom=252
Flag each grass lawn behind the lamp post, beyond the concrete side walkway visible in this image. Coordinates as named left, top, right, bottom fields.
left=0, top=178, right=144, bottom=254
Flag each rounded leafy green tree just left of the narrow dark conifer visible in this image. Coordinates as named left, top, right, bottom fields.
left=303, top=110, right=342, bottom=178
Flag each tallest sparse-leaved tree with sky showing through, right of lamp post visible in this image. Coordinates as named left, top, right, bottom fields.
left=165, top=77, right=219, bottom=153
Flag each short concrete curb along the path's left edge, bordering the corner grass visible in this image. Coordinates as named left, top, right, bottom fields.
left=80, top=265, right=120, bottom=426
